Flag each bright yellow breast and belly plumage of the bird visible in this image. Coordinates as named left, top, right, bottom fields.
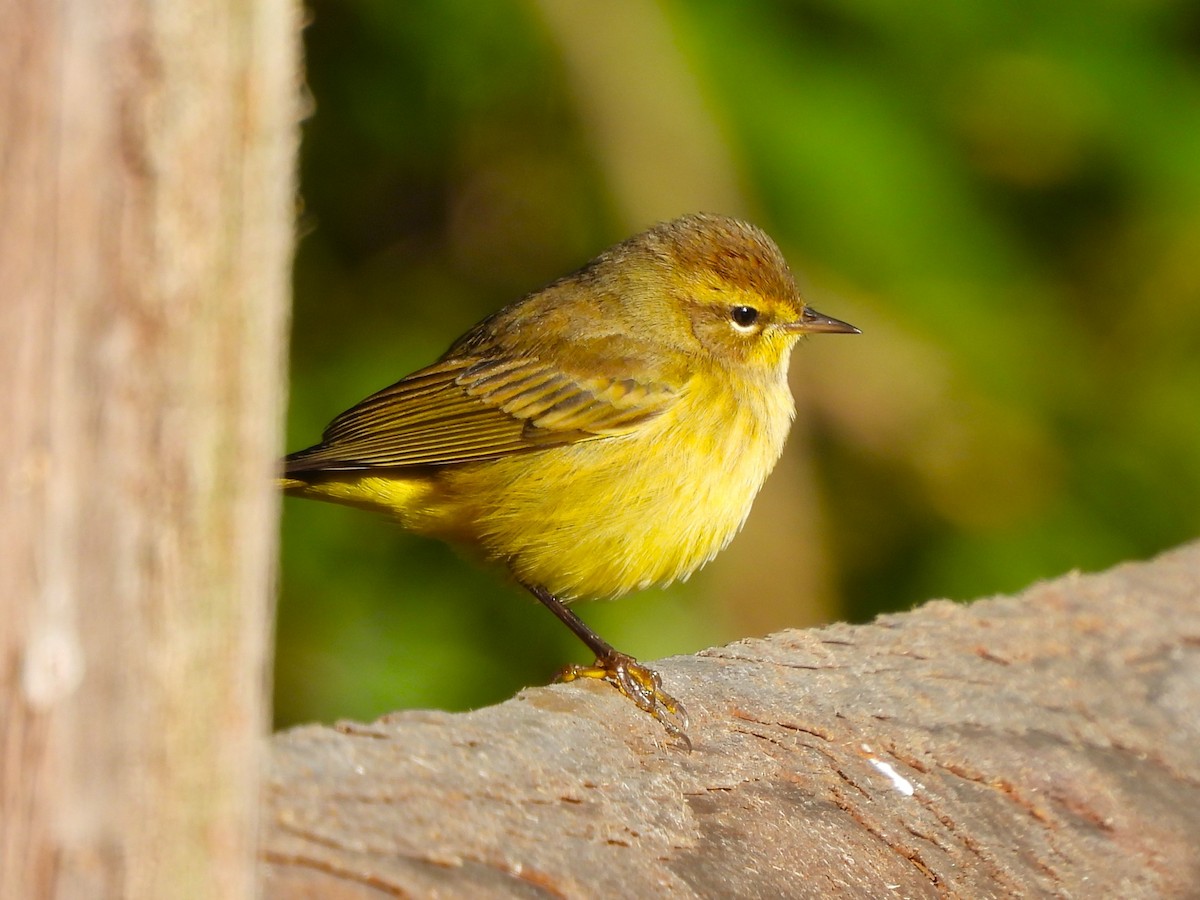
left=289, top=376, right=792, bottom=600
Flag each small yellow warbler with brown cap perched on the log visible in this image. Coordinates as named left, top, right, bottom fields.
left=281, top=214, right=858, bottom=748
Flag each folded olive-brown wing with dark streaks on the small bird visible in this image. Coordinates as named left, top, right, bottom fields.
left=278, top=358, right=678, bottom=474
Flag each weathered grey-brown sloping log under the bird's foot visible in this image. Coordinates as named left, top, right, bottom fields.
left=264, top=544, right=1200, bottom=898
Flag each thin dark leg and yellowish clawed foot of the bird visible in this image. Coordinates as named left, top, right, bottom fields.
left=524, top=584, right=691, bottom=750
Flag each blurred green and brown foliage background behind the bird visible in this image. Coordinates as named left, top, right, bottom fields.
left=276, top=0, right=1200, bottom=725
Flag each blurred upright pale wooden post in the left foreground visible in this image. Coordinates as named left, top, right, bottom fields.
left=0, top=0, right=300, bottom=899
